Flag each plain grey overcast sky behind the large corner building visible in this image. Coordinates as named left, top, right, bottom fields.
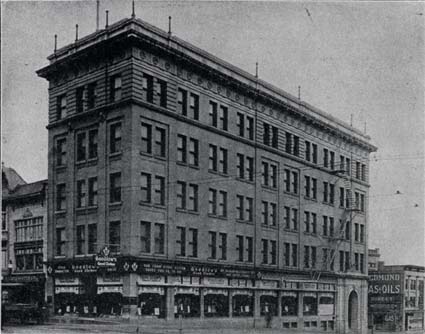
left=1, top=0, right=425, bottom=265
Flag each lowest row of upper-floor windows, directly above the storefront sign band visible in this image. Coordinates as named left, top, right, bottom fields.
left=56, top=221, right=364, bottom=272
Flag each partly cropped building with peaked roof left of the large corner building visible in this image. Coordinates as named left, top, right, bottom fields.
left=2, top=167, right=47, bottom=302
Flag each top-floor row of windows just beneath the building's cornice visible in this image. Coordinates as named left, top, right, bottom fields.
left=52, top=73, right=366, bottom=181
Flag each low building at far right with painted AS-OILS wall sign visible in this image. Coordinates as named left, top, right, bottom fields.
left=368, top=265, right=425, bottom=331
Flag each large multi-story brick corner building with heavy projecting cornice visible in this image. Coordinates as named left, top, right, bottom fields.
left=37, top=13, right=376, bottom=333
